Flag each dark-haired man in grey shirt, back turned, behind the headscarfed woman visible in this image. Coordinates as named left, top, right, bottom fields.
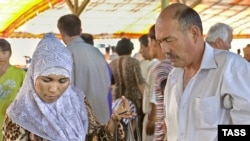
left=57, top=14, right=111, bottom=124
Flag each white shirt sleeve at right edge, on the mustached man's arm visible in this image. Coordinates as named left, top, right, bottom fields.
left=226, top=64, right=250, bottom=124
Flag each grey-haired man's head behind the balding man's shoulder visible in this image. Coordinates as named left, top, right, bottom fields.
left=206, top=23, right=233, bottom=50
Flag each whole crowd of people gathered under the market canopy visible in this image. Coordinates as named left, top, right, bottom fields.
left=0, top=3, right=250, bottom=141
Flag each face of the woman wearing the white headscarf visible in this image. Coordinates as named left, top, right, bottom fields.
left=35, top=74, right=70, bottom=103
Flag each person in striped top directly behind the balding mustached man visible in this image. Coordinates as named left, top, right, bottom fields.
left=146, top=25, right=173, bottom=141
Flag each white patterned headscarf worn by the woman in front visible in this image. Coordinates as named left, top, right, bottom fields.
left=7, top=33, right=88, bottom=141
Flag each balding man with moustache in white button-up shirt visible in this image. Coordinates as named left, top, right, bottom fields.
left=155, top=3, right=250, bottom=141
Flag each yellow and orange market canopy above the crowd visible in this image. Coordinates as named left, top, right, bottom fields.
left=0, top=0, right=250, bottom=38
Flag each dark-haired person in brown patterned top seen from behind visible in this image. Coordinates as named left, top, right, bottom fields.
left=110, top=38, right=145, bottom=140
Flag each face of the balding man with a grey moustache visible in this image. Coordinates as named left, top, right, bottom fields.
left=155, top=16, right=194, bottom=67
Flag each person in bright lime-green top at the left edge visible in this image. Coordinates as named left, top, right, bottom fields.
left=0, top=39, right=26, bottom=141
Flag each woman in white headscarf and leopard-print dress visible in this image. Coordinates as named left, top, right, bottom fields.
left=3, top=34, right=125, bottom=141
